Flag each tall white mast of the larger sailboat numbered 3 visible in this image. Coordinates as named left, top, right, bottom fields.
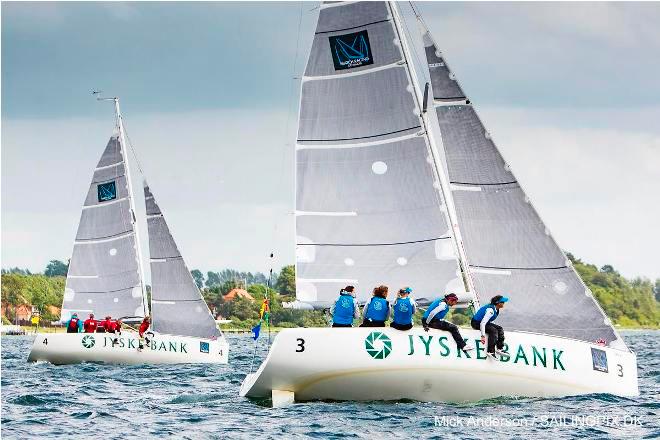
left=387, top=1, right=479, bottom=308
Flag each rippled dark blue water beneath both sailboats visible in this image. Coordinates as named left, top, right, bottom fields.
left=2, top=331, right=660, bottom=440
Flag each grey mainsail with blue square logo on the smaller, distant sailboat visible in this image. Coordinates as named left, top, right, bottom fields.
left=61, top=135, right=144, bottom=320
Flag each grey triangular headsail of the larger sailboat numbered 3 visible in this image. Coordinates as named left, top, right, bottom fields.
left=424, top=24, right=618, bottom=343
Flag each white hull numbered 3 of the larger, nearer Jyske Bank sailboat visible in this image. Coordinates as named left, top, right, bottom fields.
left=240, top=327, right=639, bottom=405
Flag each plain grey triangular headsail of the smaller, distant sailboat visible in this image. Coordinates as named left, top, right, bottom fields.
left=144, top=182, right=221, bottom=338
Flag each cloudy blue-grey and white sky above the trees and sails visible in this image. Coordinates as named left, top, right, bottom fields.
left=1, top=2, right=660, bottom=279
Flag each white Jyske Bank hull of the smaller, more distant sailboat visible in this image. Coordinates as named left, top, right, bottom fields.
left=28, top=332, right=229, bottom=365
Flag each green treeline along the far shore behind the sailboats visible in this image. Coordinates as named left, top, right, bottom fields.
left=2, top=253, right=660, bottom=328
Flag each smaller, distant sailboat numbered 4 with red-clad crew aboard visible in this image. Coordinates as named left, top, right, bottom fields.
left=28, top=98, right=229, bottom=364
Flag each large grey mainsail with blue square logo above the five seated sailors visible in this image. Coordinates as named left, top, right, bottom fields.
left=296, top=2, right=465, bottom=307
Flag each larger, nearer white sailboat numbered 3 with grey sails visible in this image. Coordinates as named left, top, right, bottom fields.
left=240, top=2, right=639, bottom=406
